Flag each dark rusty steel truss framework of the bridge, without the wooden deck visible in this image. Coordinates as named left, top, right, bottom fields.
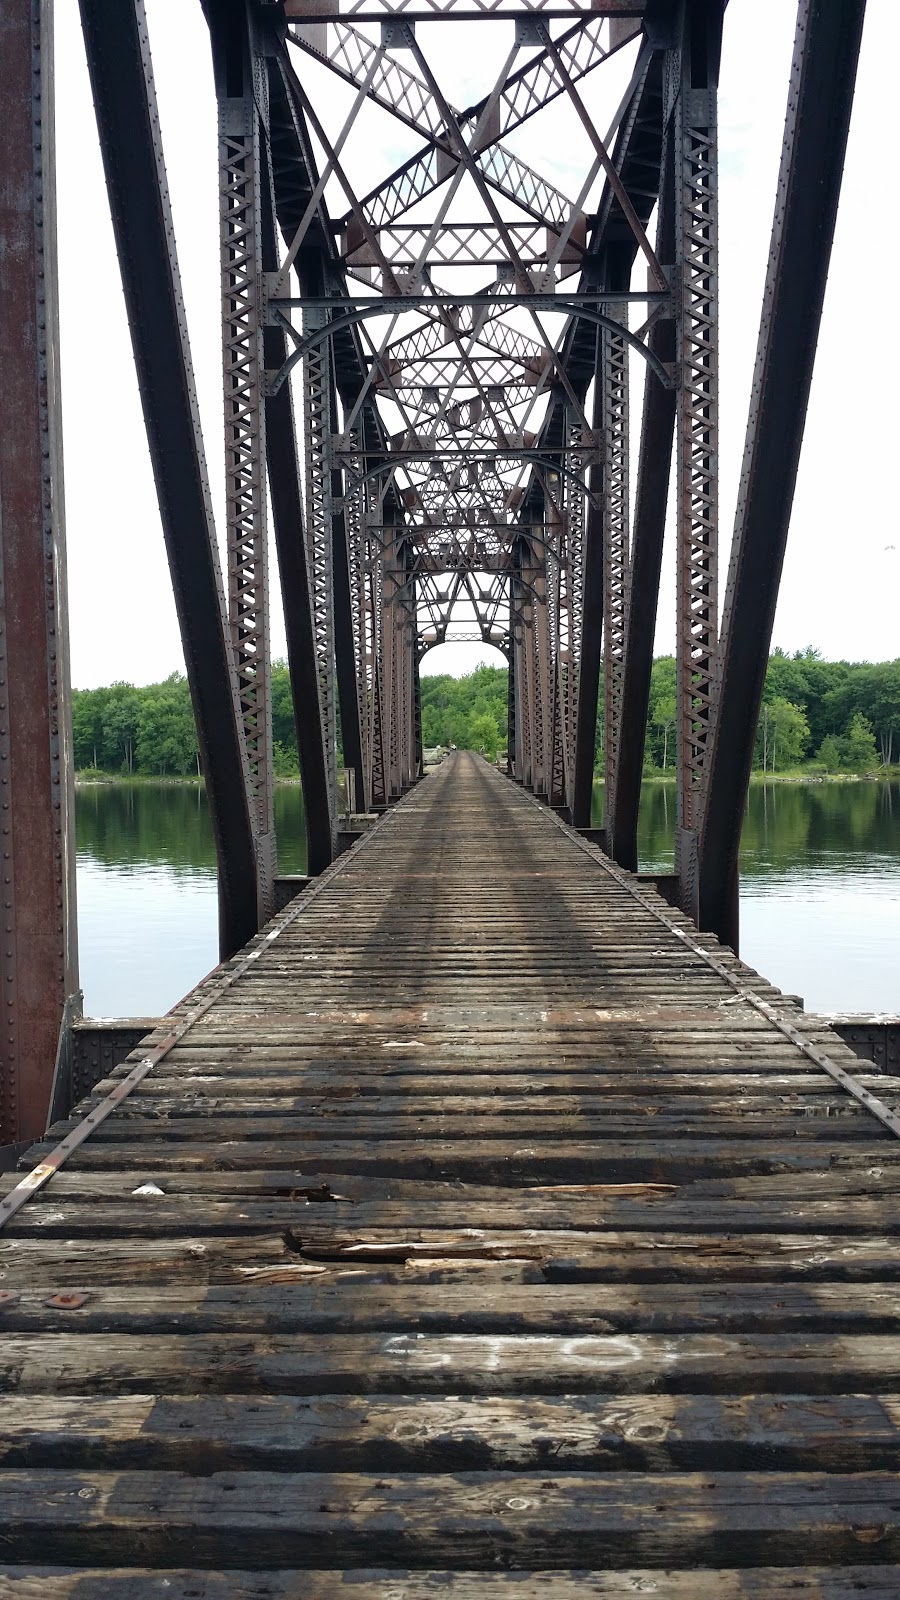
left=0, top=0, right=863, bottom=1139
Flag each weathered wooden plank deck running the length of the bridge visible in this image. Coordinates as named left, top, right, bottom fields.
left=0, top=755, right=900, bottom=1600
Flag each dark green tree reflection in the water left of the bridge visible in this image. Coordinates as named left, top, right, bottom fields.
left=75, top=782, right=306, bottom=872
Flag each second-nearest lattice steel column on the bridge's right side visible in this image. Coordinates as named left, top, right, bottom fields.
left=601, top=301, right=631, bottom=840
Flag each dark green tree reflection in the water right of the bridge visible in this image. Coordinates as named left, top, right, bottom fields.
left=594, top=782, right=900, bottom=877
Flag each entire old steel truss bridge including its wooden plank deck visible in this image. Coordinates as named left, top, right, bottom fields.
left=0, top=9, right=900, bottom=1600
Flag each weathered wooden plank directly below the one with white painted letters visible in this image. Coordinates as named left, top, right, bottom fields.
left=0, top=1394, right=900, bottom=1474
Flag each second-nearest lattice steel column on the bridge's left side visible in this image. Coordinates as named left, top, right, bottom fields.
left=303, top=307, right=338, bottom=826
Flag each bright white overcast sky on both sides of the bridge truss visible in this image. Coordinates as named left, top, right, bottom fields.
left=56, top=0, right=900, bottom=686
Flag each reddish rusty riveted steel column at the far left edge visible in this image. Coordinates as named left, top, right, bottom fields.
left=0, top=0, right=80, bottom=1144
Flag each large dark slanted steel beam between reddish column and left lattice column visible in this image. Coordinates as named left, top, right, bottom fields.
left=80, top=0, right=264, bottom=957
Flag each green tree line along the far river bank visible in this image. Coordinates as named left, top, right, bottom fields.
left=72, top=650, right=900, bottom=778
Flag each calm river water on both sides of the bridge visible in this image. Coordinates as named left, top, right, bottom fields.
left=77, top=782, right=900, bottom=1016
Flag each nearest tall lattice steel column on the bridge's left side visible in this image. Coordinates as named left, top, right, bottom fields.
left=213, top=8, right=275, bottom=915
